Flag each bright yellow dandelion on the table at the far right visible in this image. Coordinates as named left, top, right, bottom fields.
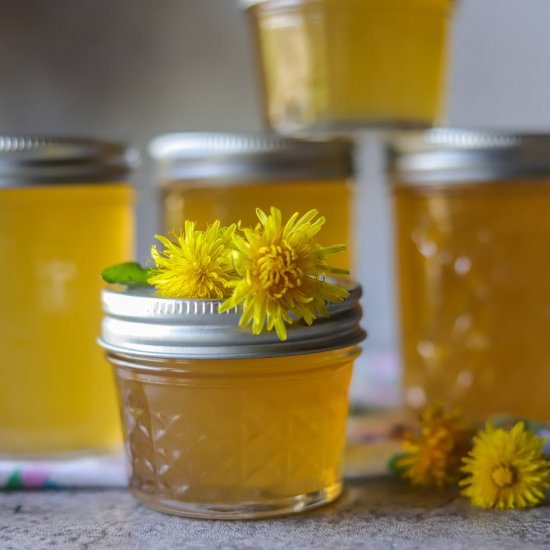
left=460, top=422, right=550, bottom=508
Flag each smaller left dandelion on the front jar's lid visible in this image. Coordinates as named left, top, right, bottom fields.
left=147, top=220, right=235, bottom=299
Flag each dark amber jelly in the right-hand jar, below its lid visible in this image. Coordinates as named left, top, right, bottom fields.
left=396, top=180, right=550, bottom=420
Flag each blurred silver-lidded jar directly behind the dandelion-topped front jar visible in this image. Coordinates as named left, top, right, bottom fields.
left=149, top=133, right=353, bottom=269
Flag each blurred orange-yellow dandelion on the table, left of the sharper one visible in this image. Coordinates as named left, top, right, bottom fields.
left=395, top=404, right=473, bottom=487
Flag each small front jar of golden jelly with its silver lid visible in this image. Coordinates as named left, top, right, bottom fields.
left=100, top=285, right=365, bottom=519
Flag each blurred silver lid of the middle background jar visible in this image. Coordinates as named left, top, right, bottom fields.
left=149, top=132, right=353, bottom=183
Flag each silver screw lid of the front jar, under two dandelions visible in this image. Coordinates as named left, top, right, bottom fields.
left=99, top=280, right=366, bottom=359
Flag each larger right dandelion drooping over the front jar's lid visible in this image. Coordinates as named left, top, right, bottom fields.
left=220, top=207, right=349, bottom=340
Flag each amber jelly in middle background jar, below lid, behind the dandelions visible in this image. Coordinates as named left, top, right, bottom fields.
left=163, top=180, right=354, bottom=269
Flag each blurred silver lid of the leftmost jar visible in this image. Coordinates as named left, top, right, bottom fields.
left=0, top=135, right=138, bottom=187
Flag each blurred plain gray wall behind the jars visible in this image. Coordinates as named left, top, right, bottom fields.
left=0, top=0, right=550, bottom=349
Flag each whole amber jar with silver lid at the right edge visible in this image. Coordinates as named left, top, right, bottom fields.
left=391, top=129, right=550, bottom=421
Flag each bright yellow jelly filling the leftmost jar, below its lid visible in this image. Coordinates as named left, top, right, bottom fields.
left=0, top=184, right=133, bottom=455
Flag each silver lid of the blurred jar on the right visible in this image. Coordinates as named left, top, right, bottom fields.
left=388, top=128, right=550, bottom=185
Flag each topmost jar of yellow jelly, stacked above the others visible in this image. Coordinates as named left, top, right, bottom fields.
left=242, top=0, right=454, bottom=134
